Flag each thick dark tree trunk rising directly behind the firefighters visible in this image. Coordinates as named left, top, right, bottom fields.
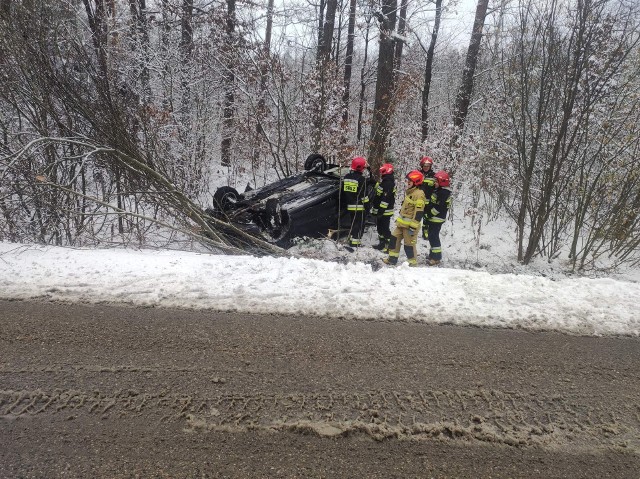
left=369, top=0, right=398, bottom=171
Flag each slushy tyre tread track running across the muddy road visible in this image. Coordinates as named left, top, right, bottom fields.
left=0, top=389, right=640, bottom=453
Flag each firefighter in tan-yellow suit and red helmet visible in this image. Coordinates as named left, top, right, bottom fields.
left=382, top=170, right=427, bottom=266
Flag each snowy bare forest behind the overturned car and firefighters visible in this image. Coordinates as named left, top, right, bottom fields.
left=0, top=0, right=640, bottom=270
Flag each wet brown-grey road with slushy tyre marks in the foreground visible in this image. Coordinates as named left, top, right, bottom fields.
left=0, top=301, right=640, bottom=479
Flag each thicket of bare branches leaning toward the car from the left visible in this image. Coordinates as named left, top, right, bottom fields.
left=0, top=0, right=279, bottom=254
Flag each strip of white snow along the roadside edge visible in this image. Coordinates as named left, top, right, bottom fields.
left=0, top=242, right=640, bottom=336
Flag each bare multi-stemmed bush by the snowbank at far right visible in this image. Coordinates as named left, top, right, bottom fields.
left=502, top=0, right=639, bottom=264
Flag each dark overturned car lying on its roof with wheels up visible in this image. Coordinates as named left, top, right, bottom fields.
left=206, top=154, right=371, bottom=248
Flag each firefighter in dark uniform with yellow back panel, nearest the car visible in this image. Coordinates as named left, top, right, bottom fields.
left=341, top=156, right=369, bottom=247
